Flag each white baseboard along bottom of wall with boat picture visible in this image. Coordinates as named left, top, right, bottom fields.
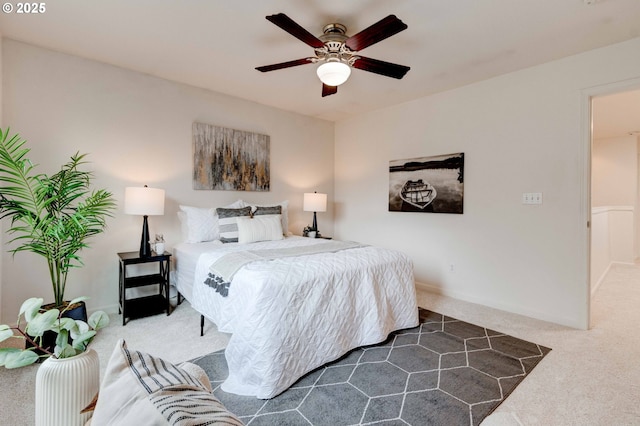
left=415, top=281, right=585, bottom=330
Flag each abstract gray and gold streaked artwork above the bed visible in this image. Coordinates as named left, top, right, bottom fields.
left=193, top=123, right=270, bottom=191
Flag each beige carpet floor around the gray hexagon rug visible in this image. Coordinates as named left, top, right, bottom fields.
left=0, top=265, right=640, bottom=426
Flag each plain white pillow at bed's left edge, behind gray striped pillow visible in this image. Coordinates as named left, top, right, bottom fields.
left=178, top=200, right=247, bottom=243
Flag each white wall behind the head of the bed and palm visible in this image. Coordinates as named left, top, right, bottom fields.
left=2, top=39, right=334, bottom=320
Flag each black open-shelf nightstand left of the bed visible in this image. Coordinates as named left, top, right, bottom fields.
left=118, top=251, right=171, bottom=325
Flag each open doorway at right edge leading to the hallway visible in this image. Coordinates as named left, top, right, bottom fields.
left=587, top=85, right=640, bottom=326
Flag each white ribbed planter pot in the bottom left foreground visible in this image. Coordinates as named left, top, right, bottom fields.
left=36, top=349, right=100, bottom=426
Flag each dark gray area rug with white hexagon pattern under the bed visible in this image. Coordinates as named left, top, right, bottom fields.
left=192, top=309, right=551, bottom=426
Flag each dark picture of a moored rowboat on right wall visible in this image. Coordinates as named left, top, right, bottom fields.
left=389, top=153, right=464, bottom=214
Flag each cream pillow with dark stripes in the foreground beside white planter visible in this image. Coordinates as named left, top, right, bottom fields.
left=91, top=339, right=242, bottom=426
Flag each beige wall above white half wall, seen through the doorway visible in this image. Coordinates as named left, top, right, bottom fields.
left=591, top=136, right=638, bottom=207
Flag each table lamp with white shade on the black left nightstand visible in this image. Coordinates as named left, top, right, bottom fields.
left=124, top=185, right=164, bottom=257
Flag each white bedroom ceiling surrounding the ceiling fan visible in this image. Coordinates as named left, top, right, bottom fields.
left=0, top=0, right=640, bottom=120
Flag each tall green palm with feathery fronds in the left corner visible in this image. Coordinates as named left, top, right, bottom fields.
left=0, top=129, right=115, bottom=310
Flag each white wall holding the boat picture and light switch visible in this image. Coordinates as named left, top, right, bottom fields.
left=335, top=38, right=640, bottom=328
